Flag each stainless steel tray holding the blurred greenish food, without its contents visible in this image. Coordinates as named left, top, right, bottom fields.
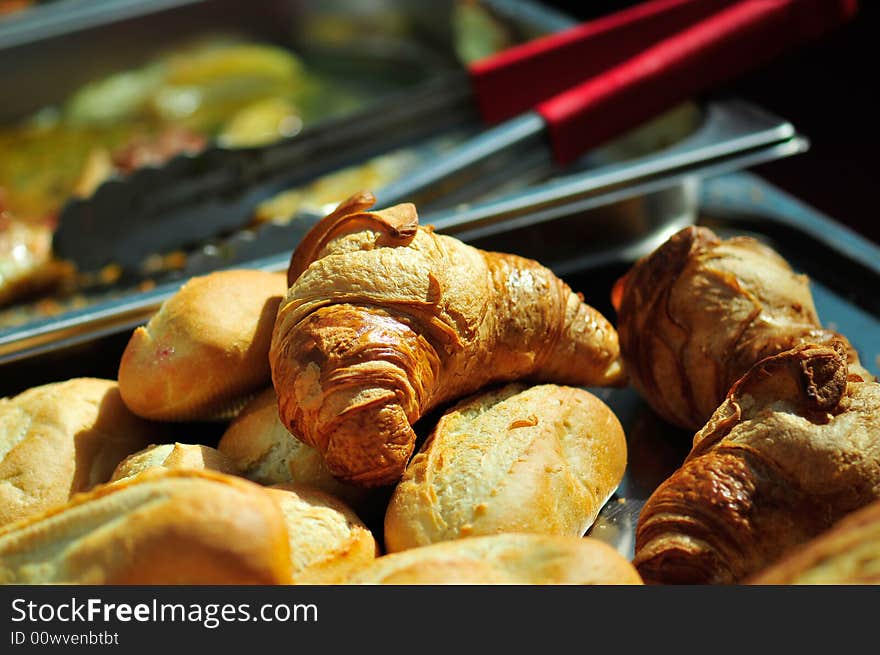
left=0, top=0, right=807, bottom=365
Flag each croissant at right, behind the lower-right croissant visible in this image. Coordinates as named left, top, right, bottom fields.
left=612, top=226, right=873, bottom=431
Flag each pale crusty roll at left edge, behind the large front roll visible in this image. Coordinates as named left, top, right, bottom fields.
left=0, top=378, right=162, bottom=525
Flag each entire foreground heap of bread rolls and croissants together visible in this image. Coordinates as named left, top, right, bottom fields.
left=0, top=193, right=880, bottom=585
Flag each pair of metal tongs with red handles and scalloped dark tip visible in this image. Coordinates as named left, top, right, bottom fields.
left=53, top=0, right=857, bottom=270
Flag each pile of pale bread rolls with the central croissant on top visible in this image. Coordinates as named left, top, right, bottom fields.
left=0, top=194, right=641, bottom=584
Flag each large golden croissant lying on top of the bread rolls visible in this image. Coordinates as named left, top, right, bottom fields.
left=269, top=193, right=625, bottom=486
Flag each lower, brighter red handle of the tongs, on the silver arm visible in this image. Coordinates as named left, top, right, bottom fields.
left=536, top=0, right=857, bottom=163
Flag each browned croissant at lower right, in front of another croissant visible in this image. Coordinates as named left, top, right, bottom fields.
left=633, top=342, right=880, bottom=584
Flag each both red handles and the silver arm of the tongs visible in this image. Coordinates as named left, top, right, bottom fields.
left=378, top=0, right=857, bottom=206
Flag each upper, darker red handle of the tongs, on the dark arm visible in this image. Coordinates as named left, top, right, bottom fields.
left=469, top=0, right=735, bottom=125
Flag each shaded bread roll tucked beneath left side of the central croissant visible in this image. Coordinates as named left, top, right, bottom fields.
left=217, top=387, right=370, bottom=510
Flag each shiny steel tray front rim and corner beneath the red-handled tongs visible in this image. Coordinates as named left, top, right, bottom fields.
left=0, top=99, right=807, bottom=365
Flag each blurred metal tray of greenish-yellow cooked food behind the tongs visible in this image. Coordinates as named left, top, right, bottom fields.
left=0, top=0, right=572, bottom=348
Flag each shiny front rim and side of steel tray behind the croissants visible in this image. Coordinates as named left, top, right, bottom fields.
left=0, top=111, right=807, bottom=366
